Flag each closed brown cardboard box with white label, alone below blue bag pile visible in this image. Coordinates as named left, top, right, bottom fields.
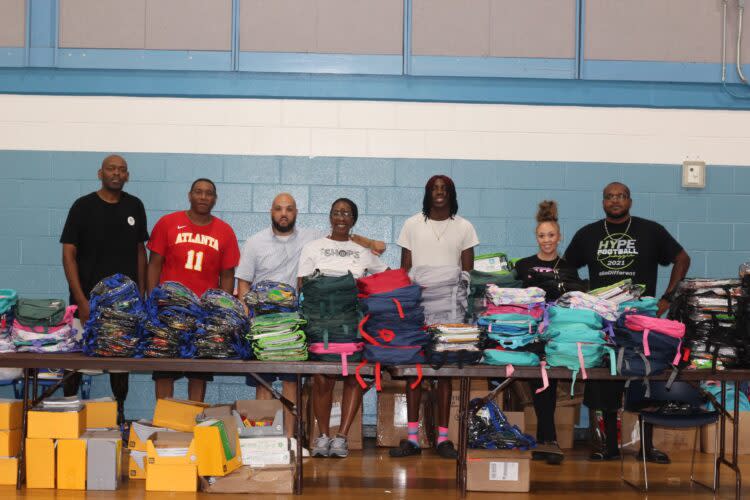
left=466, top=450, right=531, bottom=493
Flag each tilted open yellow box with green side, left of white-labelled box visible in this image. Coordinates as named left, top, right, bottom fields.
left=194, top=414, right=242, bottom=476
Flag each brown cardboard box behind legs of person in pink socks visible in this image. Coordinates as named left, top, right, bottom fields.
left=376, top=381, right=432, bottom=448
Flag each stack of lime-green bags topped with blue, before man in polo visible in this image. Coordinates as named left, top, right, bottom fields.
left=244, top=281, right=307, bottom=361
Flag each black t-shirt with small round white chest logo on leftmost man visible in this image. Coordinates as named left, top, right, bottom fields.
left=60, top=192, right=148, bottom=304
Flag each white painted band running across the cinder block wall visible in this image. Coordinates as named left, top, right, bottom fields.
left=0, top=95, right=750, bottom=165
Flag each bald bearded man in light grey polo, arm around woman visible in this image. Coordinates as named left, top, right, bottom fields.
left=235, top=193, right=385, bottom=431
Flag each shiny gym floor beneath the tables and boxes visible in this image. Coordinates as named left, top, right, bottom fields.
left=0, top=440, right=750, bottom=500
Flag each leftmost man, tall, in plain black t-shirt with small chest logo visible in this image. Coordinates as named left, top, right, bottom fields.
left=60, top=155, right=148, bottom=423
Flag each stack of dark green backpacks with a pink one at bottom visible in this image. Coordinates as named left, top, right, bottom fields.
left=301, top=272, right=363, bottom=376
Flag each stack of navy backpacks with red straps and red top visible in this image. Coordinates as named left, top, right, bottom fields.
left=357, top=269, right=426, bottom=390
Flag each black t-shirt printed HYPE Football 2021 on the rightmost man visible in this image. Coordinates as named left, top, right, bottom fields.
left=565, top=217, right=682, bottom=296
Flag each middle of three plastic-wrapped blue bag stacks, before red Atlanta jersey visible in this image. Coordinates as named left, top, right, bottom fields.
left=139, top=281, right=203, bottom=358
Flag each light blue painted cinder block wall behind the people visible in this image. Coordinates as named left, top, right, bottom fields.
left=0, top=151, right=750, bottom=423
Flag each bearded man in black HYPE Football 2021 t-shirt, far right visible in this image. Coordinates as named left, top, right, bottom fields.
left=565, top=182, right=690, bottom=463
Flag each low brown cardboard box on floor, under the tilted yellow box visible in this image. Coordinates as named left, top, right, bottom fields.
left=200, top=460, right=294, bottom=495
